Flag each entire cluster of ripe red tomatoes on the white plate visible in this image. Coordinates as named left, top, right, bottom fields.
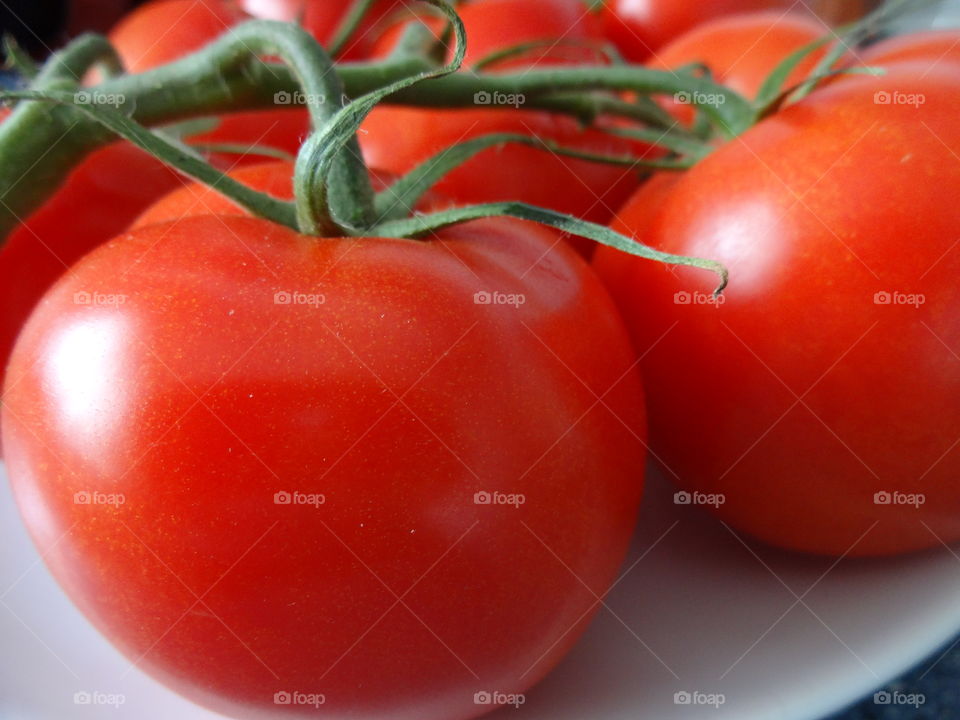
left=0, top=0, right=960, bottom=720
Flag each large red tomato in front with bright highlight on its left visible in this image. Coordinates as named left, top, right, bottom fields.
left=2, top=207, right=644, bottom=720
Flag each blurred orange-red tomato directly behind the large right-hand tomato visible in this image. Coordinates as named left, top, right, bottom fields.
left=648, top=11, right=829, bottom=99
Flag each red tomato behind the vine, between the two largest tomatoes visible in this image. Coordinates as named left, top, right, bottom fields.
left=359, top=0, right=653, bottom=253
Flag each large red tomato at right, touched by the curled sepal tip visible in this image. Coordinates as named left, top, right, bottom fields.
left=595, top=63, right=960, bottom=555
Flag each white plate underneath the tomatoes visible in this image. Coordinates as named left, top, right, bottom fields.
left=0, top=462, right=960, bottom=720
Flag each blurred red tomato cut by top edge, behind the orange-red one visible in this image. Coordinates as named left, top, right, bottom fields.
left=603, top=0, right=794, bottom=62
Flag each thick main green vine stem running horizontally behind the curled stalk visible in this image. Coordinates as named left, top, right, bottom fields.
left=0, top=14, right=754, bottom=243
